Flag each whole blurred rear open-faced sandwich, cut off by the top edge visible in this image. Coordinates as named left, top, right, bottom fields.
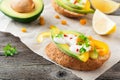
left=52, top=0, right=94, bottom=17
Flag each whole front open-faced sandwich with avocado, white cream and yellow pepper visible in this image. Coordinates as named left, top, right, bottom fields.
left=45, top=26, right=110, bottom=71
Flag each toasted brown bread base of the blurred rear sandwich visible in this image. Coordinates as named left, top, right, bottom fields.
left=52, top=0, right=84, bottom=18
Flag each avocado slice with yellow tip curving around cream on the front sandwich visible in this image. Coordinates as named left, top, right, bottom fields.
left=51, top=26, right=89, bottom=62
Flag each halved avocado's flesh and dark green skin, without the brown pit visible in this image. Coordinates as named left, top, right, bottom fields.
left=0, top=0, right=44, bottom=23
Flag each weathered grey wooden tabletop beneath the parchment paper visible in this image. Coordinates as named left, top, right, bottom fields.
left=0, top=0, right=120, bottom=80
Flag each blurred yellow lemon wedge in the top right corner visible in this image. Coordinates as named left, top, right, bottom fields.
left=90, top=0, right=120, bottom=14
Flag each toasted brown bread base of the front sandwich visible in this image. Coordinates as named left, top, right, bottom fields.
left=45, top=43, right=110, bottom=71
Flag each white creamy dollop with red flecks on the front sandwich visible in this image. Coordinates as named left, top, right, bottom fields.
left=53, top=34, right=91, bottom=54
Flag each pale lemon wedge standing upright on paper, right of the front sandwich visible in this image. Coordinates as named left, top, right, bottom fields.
left=92, top=10, right=116, bottom=35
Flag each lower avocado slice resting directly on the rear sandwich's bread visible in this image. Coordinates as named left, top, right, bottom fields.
left=55, top=0, right=94, bottom=14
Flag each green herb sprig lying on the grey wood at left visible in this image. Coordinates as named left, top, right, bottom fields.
left=3, top=44, right=18, bottom=56
